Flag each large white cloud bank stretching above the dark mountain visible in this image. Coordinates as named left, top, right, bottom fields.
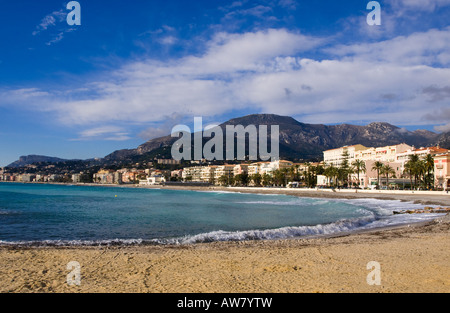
left=0, top=28, right=450, bottom=138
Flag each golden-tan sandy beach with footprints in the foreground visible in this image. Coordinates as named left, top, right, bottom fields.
left=0, top=216, right=450, bottom=293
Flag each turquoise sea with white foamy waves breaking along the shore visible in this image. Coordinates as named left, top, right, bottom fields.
left=0, top=183, right=440, bottom=246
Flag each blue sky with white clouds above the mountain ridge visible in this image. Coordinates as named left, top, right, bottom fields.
left=0, top=0, right=450, bottom=166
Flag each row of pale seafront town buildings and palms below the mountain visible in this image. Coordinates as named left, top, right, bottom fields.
left=0, top=144, right=450, bottom=190
